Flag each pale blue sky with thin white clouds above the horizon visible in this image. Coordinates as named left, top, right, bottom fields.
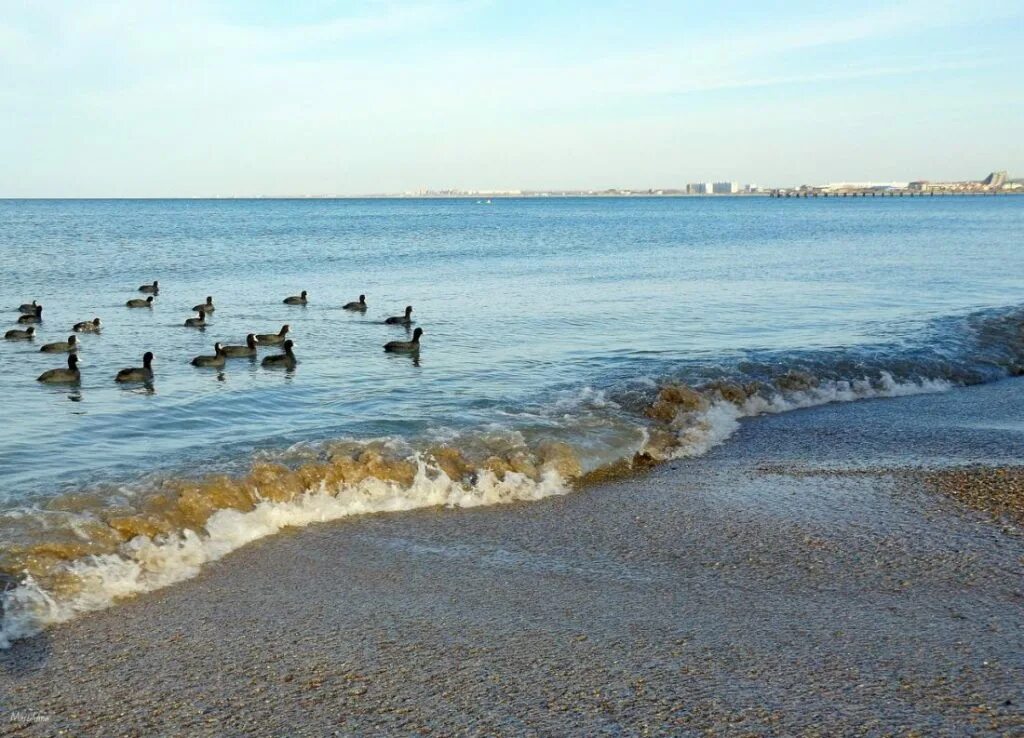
left=0, top=0, right=1024, bottom=198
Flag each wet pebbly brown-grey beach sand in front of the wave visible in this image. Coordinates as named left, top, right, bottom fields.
left=0, top=380, right=1024, bottom=736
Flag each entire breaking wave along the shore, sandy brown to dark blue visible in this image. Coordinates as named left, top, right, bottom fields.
left=0, top=308, right=1024, bottom=647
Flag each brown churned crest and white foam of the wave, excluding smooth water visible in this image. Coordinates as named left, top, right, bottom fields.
left=0, top=372, right=954, bottom=648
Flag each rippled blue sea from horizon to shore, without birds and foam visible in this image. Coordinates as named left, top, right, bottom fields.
left=0, top=197, right=1024, bottom=640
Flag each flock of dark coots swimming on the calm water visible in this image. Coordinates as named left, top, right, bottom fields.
left=4, top=280, right=423, bottom=384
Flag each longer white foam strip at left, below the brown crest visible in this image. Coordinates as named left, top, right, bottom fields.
left=0, top=457, right=569, bottom=648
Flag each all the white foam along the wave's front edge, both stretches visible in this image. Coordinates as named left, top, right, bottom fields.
left=0, top=374, right=952, bottom=648
